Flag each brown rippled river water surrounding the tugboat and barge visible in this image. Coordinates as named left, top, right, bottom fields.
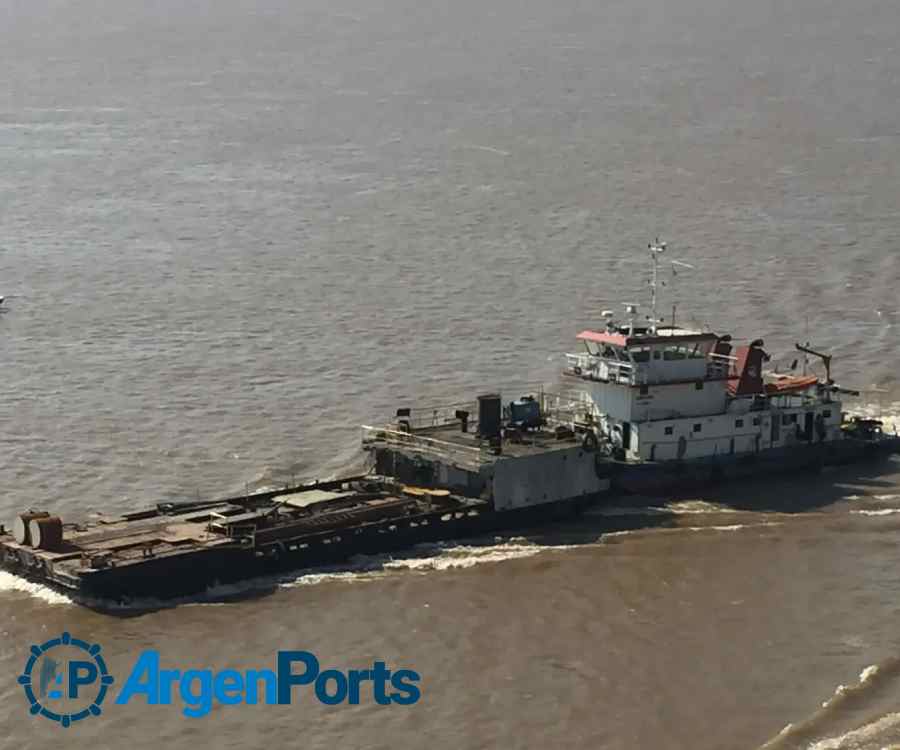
left=0, top=0, right=900, bottom=750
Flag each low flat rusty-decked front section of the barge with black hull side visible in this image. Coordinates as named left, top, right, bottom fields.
left=0, top=476, right=489, bottom=600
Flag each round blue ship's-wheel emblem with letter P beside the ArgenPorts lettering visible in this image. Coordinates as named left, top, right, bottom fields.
left=19, top=633, right=113, bottom=727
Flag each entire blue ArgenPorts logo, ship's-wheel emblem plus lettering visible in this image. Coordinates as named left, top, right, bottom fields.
left=19, top=633, right=422, bottom=727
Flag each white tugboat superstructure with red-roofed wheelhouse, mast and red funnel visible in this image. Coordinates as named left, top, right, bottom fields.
left=565, top=243, right=842, bottom=461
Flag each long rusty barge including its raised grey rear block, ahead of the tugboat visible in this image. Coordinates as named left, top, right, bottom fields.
left=0, top=396, right=610, bottom=602
